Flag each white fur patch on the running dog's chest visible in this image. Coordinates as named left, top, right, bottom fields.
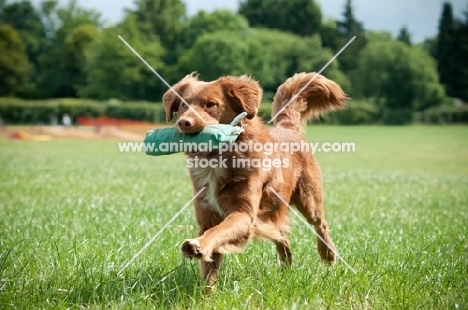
left=191, top=167, right=226, bottom=217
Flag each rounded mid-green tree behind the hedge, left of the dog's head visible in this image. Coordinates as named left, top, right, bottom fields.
left=78, top=13, right=167, bottom=101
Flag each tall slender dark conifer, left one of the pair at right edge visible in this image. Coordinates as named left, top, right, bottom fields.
left=437, top=2, right=458, bottom=96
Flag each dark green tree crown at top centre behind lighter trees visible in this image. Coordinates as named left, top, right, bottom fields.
left=239, top=0, right=322, bottom=36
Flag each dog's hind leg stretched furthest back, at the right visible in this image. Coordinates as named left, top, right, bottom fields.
left=292, top=166, right=337, bottom=263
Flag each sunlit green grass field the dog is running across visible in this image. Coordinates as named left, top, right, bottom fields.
left=0, top=126, right=468, bottom=309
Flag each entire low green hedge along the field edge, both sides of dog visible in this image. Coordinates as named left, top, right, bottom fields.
left=0, top=98, right=468, bottom=125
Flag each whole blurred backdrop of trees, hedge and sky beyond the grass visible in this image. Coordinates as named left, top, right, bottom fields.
left=0, top=0, right=468, bottom=130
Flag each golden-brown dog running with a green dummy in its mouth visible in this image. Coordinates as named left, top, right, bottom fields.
left=163, top=73, right=348, bottom=285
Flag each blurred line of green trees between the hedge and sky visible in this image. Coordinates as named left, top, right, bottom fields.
left=0, top=0, right=468, bottom=111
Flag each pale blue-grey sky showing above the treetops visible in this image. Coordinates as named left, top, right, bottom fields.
left=23, top=0, right=468, bottom=42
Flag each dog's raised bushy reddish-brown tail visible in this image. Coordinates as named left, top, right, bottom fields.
left=271, top=72, right=349, bottom=130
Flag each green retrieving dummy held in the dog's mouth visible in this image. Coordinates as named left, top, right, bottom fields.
left=143, top=112, right=247, bottom=156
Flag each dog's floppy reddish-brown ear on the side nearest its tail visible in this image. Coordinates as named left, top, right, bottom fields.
left=218, top=75, right=263, bottom=119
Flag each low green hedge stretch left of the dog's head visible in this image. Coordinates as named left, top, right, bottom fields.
left=0, top=98, right=165, bottom=124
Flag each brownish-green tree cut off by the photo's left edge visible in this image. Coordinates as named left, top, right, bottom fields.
left=0, top=23, right=31, bottom=96
